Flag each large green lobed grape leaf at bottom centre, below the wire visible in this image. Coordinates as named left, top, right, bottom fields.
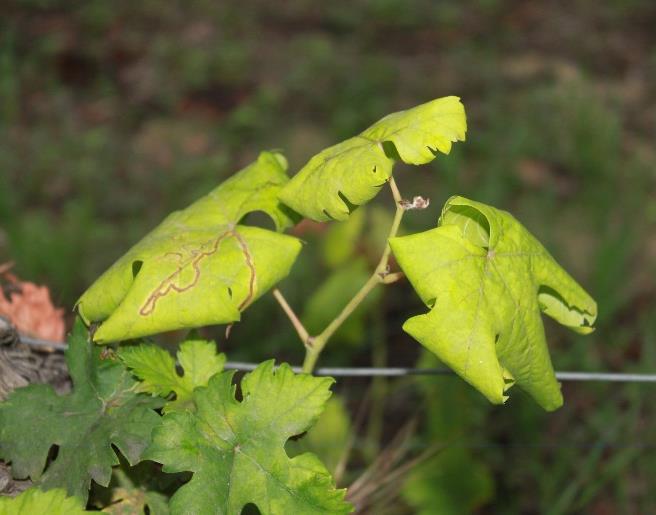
left=147, top=361, right=351, bottom=515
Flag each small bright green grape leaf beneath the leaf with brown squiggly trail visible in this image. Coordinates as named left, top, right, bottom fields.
left=118, top=340, right=226, bottom=413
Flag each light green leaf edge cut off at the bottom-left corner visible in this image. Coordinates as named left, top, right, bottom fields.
left=0, top=487, right=89, bottom=515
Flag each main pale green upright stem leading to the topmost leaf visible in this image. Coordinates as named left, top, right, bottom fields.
left=303, top=177, right=405, bottom=374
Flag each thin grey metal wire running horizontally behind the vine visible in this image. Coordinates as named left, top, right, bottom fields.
left=14, top=335, right=656, bottom=383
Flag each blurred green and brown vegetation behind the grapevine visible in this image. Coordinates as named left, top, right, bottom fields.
left=0, top=0, right=656, bottom=514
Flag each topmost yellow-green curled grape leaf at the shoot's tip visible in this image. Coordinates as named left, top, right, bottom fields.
left=280, top=97, right=467, bottom=221
